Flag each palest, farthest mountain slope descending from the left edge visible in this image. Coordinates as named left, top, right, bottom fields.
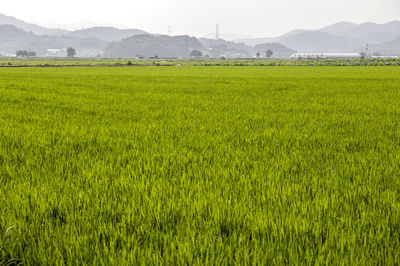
left=0, top=14, right=67, bottom=36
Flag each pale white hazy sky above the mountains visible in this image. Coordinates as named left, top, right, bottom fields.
left=0, top=0, right=400, bottom=37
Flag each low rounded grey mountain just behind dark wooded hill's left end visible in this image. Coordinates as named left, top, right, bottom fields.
left=67, top=27, right=147, bottom=42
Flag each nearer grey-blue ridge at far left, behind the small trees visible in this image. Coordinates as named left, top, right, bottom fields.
left=0, top=25, right=107, bottom=56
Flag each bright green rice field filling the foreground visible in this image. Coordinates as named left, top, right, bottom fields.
left=0, top=66, right=400, bottom=265
